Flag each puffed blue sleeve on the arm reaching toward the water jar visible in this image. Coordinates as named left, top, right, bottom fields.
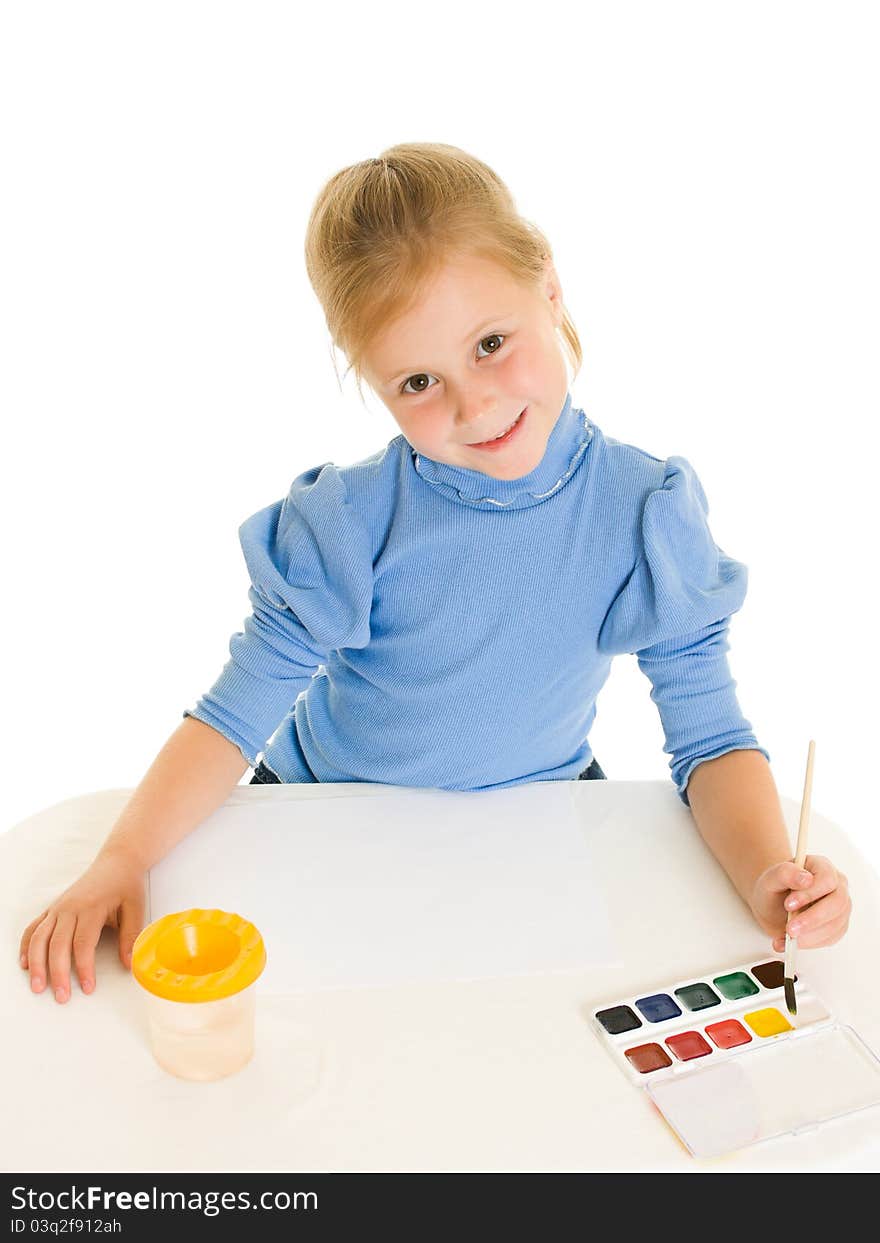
left=184, top=464, right=373, bottom=766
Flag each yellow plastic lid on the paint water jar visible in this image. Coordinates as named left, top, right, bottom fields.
left=132, top=907, right=266, bottom=1002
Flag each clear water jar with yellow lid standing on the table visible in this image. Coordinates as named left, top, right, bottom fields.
left=132, top=907, right=266, bottom=1080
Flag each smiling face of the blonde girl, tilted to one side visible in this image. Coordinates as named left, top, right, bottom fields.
left=363, top=249, right=568, bottom=480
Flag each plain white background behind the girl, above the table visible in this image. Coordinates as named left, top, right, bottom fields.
left=0, top=9, right=880, bottom=866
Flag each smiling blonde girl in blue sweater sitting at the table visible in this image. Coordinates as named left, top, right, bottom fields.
left=20, top=143, right=850, bottom=1002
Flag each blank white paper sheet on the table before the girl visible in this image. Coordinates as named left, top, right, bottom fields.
left=150, top=782, right=613, bottom=993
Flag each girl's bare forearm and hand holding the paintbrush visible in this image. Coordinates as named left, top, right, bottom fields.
left=687, top=750, right=853, bottom=953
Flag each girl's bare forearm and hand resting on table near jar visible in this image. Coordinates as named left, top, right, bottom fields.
left=20, top=717, right=250, bottom=1002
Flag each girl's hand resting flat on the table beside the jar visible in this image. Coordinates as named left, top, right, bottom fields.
left=20, top=854, right=147, bottom=1003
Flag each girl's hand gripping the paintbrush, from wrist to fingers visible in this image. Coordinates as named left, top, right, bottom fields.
left=752, top=855, right=853, bottom=953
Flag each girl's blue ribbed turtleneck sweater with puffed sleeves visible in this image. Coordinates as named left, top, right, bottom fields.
left=184, top=393, right=769, bottom=803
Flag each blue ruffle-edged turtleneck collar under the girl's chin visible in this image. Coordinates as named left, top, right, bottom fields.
left=410, top=393, right=593, bottom=510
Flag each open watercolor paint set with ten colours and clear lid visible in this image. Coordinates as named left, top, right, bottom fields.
left=593, top=958, right=880, bottom=1157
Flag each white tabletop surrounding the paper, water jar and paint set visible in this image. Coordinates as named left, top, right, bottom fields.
left=0, top=782, right=880, bottom=1172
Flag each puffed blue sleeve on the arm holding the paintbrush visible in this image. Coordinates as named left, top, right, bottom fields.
left=599, top=456, right=769, bottom=807
